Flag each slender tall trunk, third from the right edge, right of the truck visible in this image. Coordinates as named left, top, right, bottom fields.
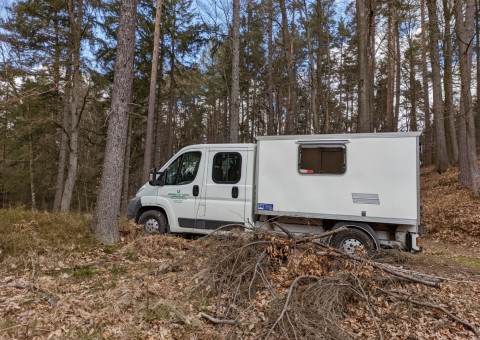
left=427, top=0, right=450, bottom=173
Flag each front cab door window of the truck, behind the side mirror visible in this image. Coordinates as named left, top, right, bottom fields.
left=165, top=151, right=202, bottom=185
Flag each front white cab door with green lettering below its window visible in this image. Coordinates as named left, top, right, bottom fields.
left=159, top=150, right=205, bottom=232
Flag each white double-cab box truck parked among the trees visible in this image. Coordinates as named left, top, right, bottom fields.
left=128, top=132, right=423, bottom=251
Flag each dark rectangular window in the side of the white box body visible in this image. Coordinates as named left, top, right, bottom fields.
left=298, top=145, right=346, bottom=174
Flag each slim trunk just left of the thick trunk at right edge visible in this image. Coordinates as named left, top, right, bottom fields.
left=443, top=0, right=458, bottom=164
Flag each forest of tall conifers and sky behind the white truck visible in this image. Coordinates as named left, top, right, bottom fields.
left=0, top=0, right=480, bottom=212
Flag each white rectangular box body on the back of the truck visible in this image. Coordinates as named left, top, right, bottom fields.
left=255, top=132, right=420, bottom=225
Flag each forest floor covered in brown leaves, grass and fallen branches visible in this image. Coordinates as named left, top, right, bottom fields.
left=0, top=168, right=480, bottom=339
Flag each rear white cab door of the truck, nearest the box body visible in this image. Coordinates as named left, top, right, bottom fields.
left=195, top=148, right=248, bottom=232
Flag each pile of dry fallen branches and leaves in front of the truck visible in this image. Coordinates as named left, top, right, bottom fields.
left=199, top=229, right=480, bottom=339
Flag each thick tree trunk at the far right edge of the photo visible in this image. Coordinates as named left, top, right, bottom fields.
left=455, top=0, right=480, bottom=194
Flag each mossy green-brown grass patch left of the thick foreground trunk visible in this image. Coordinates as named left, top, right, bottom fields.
left=0, top=209, right=97, bottom=262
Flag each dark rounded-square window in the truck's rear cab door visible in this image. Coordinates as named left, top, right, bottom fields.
left=212, top=152, right=242, bottom=184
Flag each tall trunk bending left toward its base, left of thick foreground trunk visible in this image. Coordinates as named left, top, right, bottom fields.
left=60, top=0, right=83, bottom=212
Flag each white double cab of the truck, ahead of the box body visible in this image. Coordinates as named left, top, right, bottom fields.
left=128, top=144, right=256, bottom=234
